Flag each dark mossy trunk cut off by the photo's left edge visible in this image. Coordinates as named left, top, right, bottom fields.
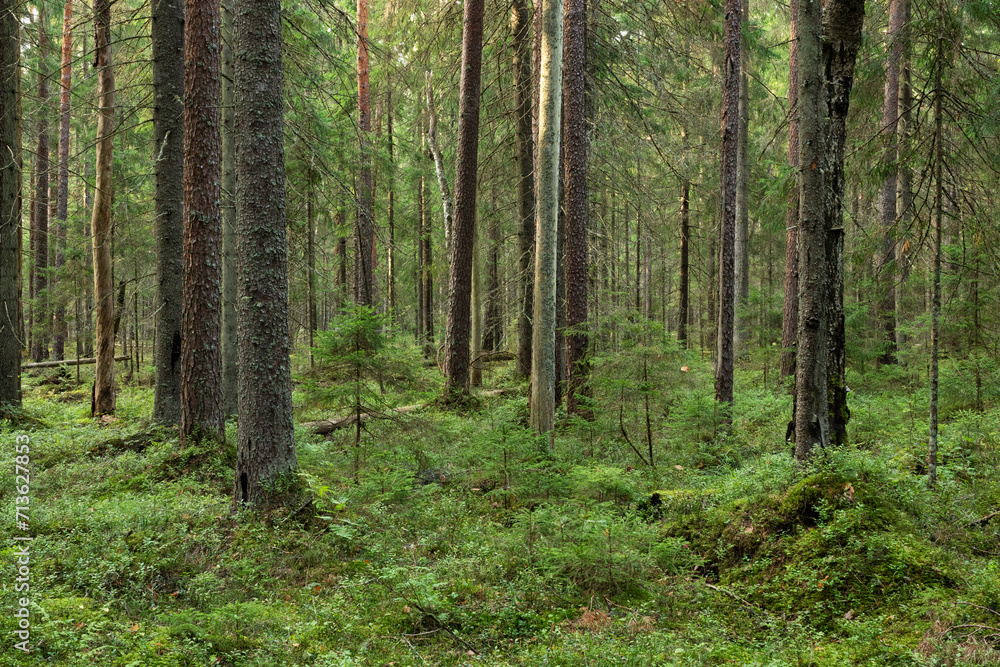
left=0, top=0, right=21, bottom=413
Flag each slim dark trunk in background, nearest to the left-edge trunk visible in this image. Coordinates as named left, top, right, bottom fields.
left=31, top=3, right=50, bottom=362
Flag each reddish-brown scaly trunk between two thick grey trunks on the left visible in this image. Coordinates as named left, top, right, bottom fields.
left=181, top=0, right=225, bottom=440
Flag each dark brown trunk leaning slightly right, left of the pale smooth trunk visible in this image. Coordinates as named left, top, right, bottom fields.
left=444, top=0, right=483, bottom=401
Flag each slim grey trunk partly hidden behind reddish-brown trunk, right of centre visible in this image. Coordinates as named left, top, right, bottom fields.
left=733, top=0, right=750, bottom=355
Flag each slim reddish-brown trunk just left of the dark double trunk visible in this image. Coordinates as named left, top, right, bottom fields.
left=780, top=0, right=799, bottom=378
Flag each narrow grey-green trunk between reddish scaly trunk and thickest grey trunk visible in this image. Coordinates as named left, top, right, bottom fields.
left=222, top=0, right=238, bottom=418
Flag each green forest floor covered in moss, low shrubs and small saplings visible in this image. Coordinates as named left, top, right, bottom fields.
left=0, top=342, right=1000, bottom=667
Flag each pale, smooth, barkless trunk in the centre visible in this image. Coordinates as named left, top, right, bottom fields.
left=531, top=0, right=563, bottom=440
